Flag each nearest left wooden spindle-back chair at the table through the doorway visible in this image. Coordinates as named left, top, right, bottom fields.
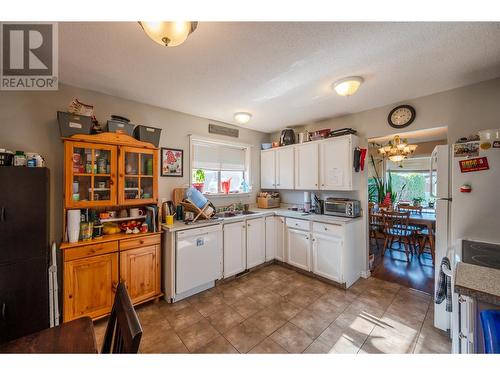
left=382, top=211, right=415, bottom=262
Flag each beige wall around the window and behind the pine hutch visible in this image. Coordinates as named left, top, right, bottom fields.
left=0, top=85, right=269, bottom=241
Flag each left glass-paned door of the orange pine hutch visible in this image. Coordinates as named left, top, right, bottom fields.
left=65, top=142, right=116, bottom=208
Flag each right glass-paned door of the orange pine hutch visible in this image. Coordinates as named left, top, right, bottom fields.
left=119, top=147, right=157, bottom=204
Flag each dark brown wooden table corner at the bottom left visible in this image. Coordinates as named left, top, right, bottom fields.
left=0, top=317, right=98, bottom=354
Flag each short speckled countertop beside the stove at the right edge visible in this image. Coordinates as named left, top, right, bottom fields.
left=455, top=262, right=500, bottom=305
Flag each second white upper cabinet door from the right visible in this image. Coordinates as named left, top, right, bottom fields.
left=295, top=142, right=319, bottom=190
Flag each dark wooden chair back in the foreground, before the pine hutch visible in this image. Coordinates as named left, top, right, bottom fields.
left=101, top=283, right=142, bottom=354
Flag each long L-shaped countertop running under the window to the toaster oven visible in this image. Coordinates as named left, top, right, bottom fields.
left=162, top=207, right=362, bottom=232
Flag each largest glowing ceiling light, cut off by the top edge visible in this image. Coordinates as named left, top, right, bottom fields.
left=139, top=21, right=198, bottom=47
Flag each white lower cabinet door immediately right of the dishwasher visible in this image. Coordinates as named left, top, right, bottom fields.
left=224, top=221, right=247, bottom=278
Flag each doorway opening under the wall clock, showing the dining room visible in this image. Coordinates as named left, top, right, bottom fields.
left=368, top=128, right=447, bottom=294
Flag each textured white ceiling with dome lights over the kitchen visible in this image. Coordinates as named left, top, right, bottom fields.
left=59, top=22, right=500, bottom=132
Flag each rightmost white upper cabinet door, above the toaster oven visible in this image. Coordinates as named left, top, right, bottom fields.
left=319, top=135, right=359, bottom=190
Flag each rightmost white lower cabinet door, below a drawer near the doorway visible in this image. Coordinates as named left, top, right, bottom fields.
left=312, top=233, right=344, bottom=283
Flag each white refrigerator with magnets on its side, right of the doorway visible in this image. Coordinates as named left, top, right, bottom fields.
left=431, top=145, right=500, bottom=334
